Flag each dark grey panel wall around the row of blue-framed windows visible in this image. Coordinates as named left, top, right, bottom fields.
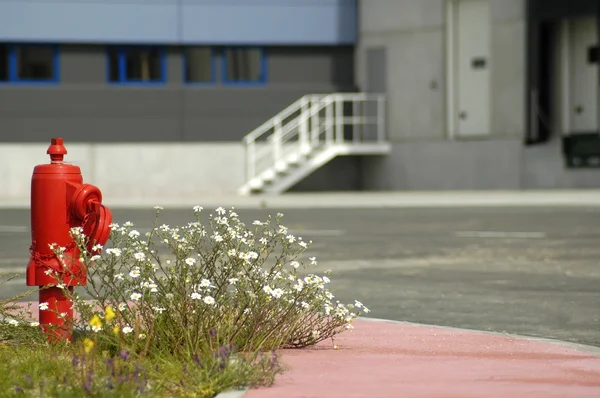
left=0, top=45, right=354, bottom=142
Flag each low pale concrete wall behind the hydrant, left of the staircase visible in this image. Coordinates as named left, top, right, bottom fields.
left=0, top=142, right=244, bottom=204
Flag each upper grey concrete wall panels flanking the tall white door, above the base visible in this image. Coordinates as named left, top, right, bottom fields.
left=356, top=0, right=525, bottom=142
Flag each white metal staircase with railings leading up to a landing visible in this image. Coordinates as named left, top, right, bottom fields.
left=238, top=93, right=390, bottom=195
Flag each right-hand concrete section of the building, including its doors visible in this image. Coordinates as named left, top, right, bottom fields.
left=356, top=0, right=600, bottom=190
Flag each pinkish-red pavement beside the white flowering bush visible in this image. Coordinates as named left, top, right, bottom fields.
left=244, top=320, right=600, bottom=398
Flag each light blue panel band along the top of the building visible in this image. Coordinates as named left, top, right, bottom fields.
left=0, top=0, right=356, bottom=45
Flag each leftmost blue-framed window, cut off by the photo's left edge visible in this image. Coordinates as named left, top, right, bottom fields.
left=0, top=43, right=60, bottom=84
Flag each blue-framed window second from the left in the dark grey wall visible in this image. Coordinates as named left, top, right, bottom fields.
left=106, top=46, right=167, bottom=85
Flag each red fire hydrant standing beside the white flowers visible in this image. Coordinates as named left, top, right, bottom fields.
left=27, top=138, right=112, bottom=341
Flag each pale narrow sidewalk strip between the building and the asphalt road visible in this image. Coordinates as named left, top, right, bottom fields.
left=5, top=189, right=600, bottom=209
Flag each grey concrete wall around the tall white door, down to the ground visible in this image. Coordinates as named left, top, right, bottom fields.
left=356, top=0, right=600, bottom=190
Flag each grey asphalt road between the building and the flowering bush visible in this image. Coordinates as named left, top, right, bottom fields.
left=0, top=207, right=600, bottom=347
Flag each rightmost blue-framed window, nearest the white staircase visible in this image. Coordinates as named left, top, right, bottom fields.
left=223, top=48, right=266, bottom=84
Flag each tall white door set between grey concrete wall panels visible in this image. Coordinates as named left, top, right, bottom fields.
left=452, top=0, right=490, bottom=137
